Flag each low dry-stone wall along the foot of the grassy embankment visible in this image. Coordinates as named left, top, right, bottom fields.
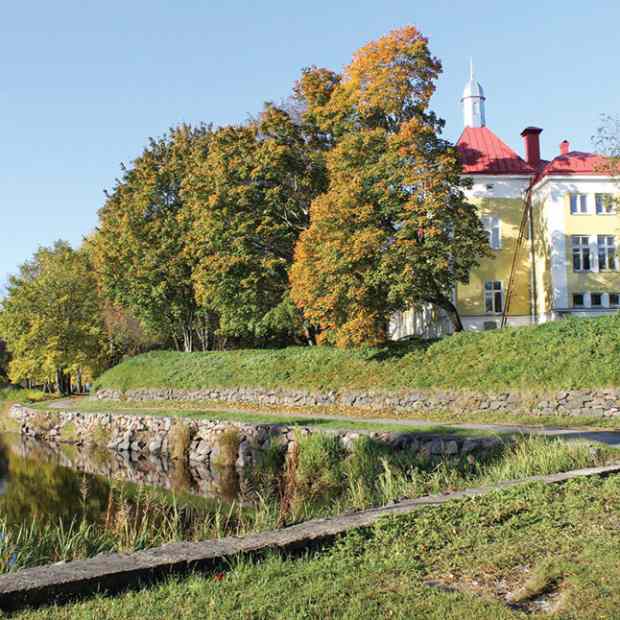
left=96, top=388, right=620, bottom=417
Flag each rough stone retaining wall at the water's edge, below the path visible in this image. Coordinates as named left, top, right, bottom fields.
left=11, top=405, right=500, bottom=464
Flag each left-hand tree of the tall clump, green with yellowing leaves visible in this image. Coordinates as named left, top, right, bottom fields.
left=92, top=125, right=211, bottom=351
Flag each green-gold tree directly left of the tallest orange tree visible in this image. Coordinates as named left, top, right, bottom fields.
left=184, top=104, right=326, bottom=341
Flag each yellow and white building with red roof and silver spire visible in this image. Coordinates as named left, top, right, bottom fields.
left=390, top=70, right=620, bottom=339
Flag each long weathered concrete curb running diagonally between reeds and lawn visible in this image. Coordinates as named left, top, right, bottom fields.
left=0, top=463, right=620, bottom=611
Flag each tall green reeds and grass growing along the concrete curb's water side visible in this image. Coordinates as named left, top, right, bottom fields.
left=0, top=435, right=611, bottom=572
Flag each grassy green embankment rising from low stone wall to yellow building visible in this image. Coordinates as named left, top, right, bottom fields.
left=97, top=314, right=620, bottom=390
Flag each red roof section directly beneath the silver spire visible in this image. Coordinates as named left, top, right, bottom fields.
left=456, top=127, right=535, bottom=174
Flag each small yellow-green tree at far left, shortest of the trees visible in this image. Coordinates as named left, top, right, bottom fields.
left=0, top=242, right=105, bottom=394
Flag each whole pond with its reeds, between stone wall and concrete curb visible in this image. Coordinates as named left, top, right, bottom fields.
left=0, top=433, right=611, bottom=572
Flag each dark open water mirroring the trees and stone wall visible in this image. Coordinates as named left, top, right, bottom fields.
left=0, top=434, right=252, bottom=525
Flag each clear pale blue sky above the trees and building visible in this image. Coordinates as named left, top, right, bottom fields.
left=0, top=0, right=620, bottom=284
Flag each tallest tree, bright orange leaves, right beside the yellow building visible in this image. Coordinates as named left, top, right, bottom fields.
left=291, top=27, right=487, bottom=346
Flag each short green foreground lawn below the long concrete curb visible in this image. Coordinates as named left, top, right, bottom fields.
left=17, top=476, right=620, bottom=620
